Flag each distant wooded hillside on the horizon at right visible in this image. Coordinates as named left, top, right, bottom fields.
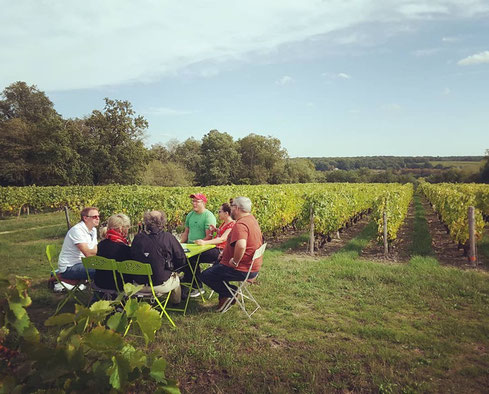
left=308, top=156, right=483, bottom=171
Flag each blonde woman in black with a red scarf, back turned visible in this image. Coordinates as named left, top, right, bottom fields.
left=94, top=213, right=131, bottom=290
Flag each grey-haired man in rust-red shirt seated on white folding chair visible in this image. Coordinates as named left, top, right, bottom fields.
left=201, top=197, right=263, bottom=312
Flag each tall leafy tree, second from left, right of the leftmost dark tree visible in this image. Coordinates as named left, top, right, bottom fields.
left=85, top=98, right=149, bottom=184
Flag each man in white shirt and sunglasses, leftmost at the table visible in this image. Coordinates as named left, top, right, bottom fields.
left=58, top=207, right=100, bottom=279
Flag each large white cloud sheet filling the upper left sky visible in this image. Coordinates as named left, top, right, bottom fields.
left=0, top=0, right=489, bottom=91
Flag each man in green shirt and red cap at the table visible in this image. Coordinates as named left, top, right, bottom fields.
left=180, top=193, right=216, bottom=297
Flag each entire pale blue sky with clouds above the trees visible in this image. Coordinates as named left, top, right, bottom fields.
left=0, top=0, right=489, bottom=157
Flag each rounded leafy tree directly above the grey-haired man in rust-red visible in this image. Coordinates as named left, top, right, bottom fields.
left=238, top=133, right=288, bottom=184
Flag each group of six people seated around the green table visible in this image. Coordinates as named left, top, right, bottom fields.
left=54, top=193, right=263, bottom=311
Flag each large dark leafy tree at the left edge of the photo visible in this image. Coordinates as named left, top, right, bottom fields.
left=0, top=82, right=82, bottom=185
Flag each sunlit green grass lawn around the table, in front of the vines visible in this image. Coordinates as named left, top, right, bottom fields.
left=0, top=211, right=489, bottom=393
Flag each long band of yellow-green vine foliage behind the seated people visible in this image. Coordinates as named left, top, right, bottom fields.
left=0, top=183, right=413, bottom=241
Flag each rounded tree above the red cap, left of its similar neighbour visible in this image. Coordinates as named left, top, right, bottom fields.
left=196, top=130, right=240, bottom=186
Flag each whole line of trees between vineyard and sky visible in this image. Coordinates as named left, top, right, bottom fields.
left=0, top=81, right=489, bottom=186
